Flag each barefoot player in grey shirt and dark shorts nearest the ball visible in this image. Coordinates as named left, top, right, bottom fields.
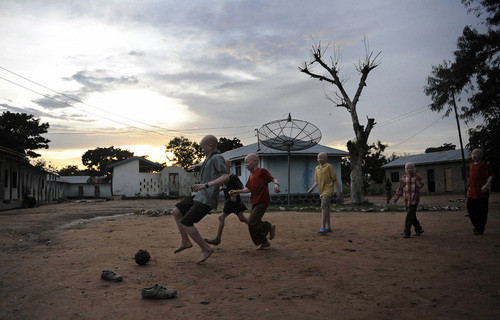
left=173, top=135, right=229, bottom=263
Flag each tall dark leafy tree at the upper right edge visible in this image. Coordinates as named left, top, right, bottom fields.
left=424, top=0, right=500, bottom=174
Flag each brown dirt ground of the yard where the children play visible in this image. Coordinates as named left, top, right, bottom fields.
left=0, top=194, right=500, bottom=319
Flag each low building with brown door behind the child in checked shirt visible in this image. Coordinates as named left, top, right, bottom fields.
left=382, top=150, right=470, bottom=194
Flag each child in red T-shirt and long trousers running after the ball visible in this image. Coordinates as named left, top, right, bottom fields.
left=229, top=153, right=280, bottom=250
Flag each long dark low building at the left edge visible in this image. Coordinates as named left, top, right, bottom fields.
left=0, top=147, right=60, bottom=210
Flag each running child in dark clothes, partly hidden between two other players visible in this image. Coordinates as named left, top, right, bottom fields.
left=205, top=159, right=248, bottom=246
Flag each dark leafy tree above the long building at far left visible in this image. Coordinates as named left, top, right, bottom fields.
left=0, top=111, right=50, bottom=158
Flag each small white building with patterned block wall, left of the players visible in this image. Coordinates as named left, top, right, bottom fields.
left=108, top=157, right=195, bottom=198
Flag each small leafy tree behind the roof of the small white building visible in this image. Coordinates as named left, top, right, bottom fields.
left=82, top=146, right=134, bottom=176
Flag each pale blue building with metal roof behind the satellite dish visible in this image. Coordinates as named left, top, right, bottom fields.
left=222, top=143, right=349, bottom=204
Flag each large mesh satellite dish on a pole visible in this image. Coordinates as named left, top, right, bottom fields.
left=257, top=114, right=321, bottom=206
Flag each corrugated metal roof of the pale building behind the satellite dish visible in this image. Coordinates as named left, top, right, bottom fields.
left=222, top=143, right=349, bottom=160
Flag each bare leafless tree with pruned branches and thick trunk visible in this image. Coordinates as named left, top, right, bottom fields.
left=299, top=37, right=381, bottom=203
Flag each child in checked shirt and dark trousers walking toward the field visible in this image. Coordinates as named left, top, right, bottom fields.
left=394, top=162, right=424, bottom=238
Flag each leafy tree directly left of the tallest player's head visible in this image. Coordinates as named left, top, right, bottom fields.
left=165, top=136, right=204, bottom=170
